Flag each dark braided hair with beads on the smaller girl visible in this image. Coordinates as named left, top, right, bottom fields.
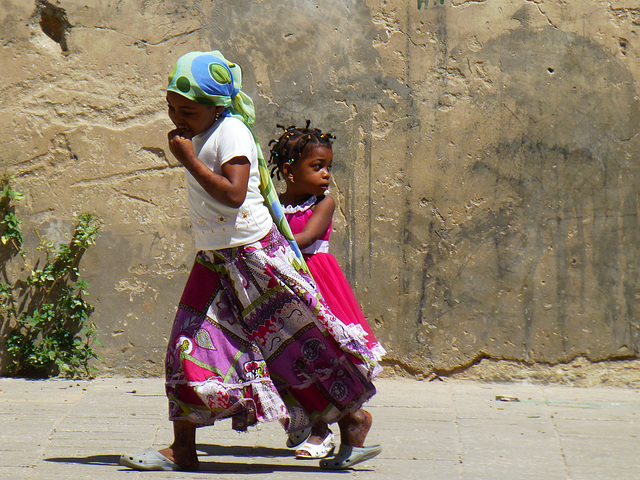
left=269, top=120, right=336, bottom=180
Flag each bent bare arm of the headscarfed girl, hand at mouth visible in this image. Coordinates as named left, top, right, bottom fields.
left=169, top=130, right=251, bottom=208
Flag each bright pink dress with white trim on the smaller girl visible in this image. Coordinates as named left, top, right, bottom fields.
left=284, top=196, right=386, bottom=360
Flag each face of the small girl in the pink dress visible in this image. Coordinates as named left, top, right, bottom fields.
left=287, top=145, right=333, bottom=196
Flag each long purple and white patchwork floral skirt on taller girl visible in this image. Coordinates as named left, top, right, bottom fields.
left=165, top=228, right=380, bottom=431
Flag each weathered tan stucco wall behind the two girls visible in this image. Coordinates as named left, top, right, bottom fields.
left=0, top=0, right=640, bottom=378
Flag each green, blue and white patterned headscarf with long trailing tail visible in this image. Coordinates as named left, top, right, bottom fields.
left=167, top=50, right=309, bottom=272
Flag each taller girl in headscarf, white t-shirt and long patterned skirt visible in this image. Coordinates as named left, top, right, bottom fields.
left=120, top=51, right=379, bottom=470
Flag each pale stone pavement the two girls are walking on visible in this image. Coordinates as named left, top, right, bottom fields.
left=0, top=378, right=640, bottom=480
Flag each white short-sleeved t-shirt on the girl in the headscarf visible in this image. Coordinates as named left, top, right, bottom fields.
left=185, top=117, right=273, bottom=250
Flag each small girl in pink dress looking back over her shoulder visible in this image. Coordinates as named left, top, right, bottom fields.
left=270, top=121, right=385, bottom=464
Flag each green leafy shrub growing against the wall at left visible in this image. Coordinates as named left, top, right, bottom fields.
left=0, top=176, right=100, bottom=377
